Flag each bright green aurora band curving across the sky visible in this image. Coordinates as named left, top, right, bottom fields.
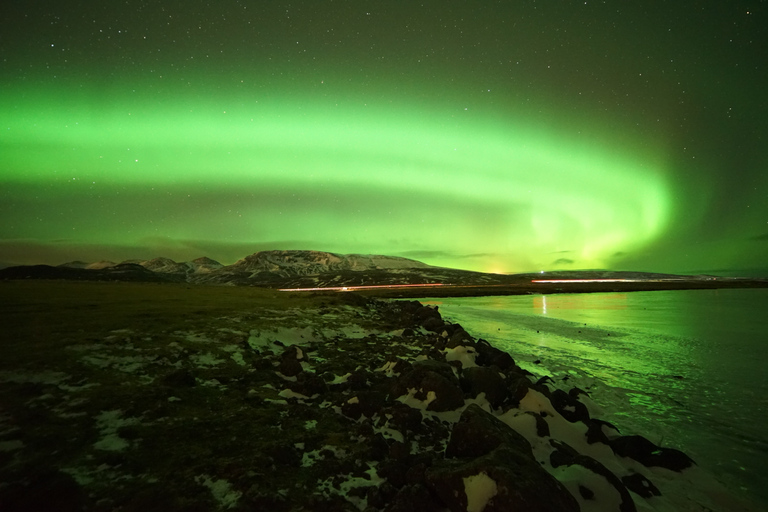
left=0, top=85, right=672, bottom=272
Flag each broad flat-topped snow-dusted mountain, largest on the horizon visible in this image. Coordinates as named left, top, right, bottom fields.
left=224, top=251, right=430, bottom=277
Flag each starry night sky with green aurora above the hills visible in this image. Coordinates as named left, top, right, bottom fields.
left=0, top=0, right=768, bottom=272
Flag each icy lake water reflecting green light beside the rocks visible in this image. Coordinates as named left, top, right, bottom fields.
left=423, top=289, right=768, bottom=510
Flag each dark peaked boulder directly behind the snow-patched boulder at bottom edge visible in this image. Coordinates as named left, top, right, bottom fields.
left=445, top=404, right=534, bottom=460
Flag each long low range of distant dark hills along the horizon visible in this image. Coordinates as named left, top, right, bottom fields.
left=0, top=251, right=764, bottom=291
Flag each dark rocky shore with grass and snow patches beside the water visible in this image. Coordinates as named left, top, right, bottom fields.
left=0, top=283, right=749, bottom=512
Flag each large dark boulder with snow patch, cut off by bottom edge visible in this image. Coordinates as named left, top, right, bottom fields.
left=426, top=444, right=579, bottom=512
